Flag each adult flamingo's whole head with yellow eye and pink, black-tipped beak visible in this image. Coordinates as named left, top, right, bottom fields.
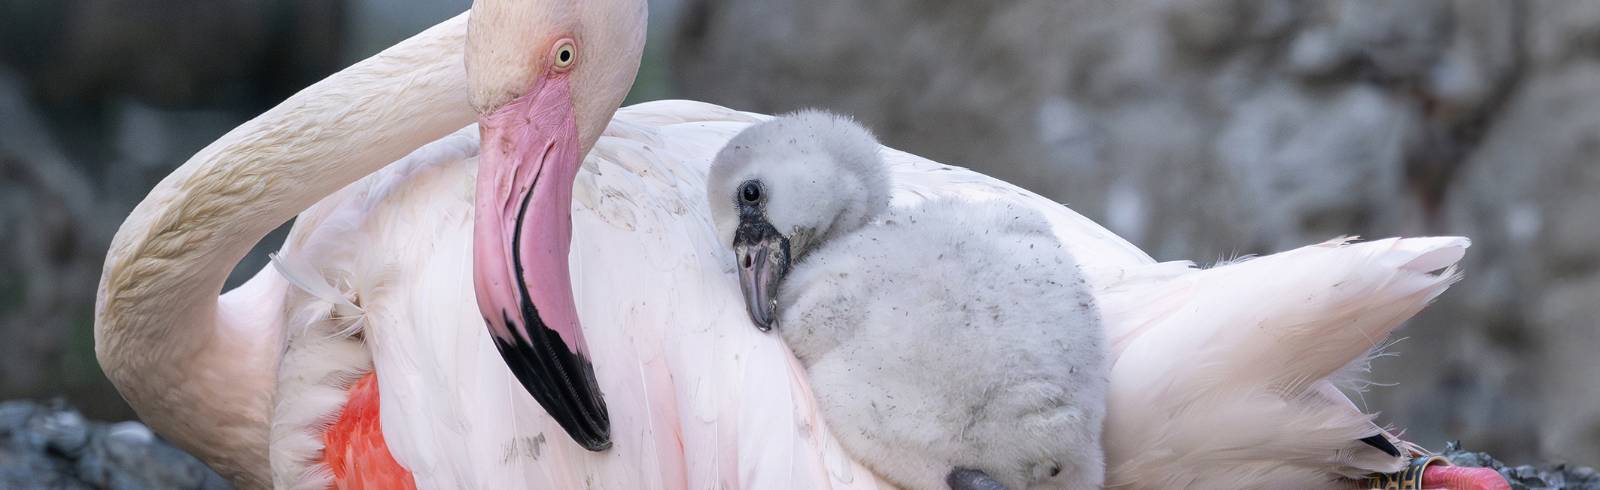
left=466, top=0, right=645, bottom=450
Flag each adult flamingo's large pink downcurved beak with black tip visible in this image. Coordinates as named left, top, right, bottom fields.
left=472, top=75, right=611, bottom=452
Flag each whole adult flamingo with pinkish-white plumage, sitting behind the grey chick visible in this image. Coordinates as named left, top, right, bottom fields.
left=96, top=0, right=1504, bottom=488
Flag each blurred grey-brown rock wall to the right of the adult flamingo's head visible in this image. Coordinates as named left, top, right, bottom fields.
left=672, top=0, right=1600, bottom=464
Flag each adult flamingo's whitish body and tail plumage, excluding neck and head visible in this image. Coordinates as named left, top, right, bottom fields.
left=262, top=101, right=1467, bottom=488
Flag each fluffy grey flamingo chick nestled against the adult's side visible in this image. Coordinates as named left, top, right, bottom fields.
left=707, top=110, right=1107, bottom=488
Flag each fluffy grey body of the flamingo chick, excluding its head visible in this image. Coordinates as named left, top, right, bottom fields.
left=774, top=200, right=1107, bottom=488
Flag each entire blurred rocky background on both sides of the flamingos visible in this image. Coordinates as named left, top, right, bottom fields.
left=0, top=0, right=1600, bottom=483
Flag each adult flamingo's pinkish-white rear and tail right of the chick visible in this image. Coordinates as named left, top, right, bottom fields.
left=1099, top=237, right=1469, bottom=488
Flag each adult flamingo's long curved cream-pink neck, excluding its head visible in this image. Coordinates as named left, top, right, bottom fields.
left=94, top=14, right=475, bottom=486
